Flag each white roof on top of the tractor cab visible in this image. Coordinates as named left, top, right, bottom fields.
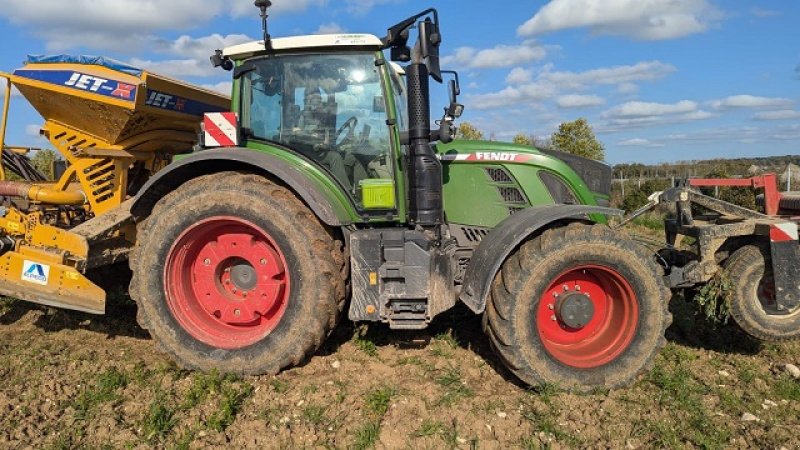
left=223, top=34, right=383, bottom=59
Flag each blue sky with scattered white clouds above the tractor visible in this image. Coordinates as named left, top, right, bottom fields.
left=0, top=0, right=800, bottom=164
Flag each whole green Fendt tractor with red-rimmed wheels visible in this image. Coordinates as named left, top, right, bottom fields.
left=130, top=1, right=670, bottom=389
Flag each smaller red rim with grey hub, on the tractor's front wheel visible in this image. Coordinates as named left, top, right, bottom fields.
left=536, top=265, right=639, bottom=369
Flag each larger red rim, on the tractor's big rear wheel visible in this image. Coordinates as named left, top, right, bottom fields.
left=164, top=216, right=290, bottom=350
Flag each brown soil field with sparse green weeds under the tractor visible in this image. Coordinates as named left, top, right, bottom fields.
left=0, top=268, right=800, bottom=449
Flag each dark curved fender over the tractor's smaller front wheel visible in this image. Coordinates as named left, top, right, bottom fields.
left=460, top=205, right=624, bottom=314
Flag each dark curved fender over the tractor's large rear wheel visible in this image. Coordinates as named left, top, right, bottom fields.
left=131, top=148, right=352, bottom=226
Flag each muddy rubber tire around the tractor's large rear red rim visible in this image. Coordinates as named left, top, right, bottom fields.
left=130, top=172, right=348, bottom=375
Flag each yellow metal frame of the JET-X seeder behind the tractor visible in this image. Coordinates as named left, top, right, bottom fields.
left=0, top=64, right=229, bottom=314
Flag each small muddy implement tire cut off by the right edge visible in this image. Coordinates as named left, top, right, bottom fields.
left=724, top=245, right=800, bottom=342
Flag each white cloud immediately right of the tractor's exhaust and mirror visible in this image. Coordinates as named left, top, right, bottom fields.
left=442, top=41, right=547, bottom=69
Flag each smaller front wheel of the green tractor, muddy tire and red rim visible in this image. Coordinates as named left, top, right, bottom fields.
left=484, top=223, right=672, bottom=391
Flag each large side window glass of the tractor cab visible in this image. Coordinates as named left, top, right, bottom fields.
left=242, top=53, right=392, bottom=205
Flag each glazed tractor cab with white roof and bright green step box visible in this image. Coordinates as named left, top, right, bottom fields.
left=222, top=35, right=407, bottom=210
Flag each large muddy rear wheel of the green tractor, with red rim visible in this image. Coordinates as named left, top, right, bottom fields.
left=131, top=172, right=346, bottom=374
